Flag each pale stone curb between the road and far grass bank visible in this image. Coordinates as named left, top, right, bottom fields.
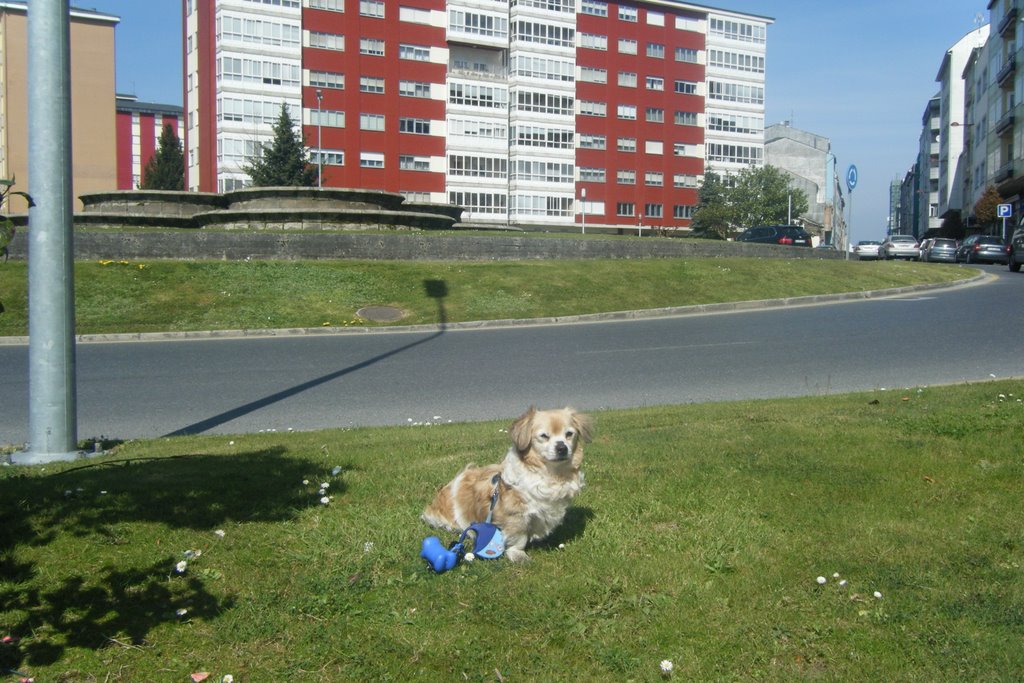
left=0, top=272, right=995, bottom=346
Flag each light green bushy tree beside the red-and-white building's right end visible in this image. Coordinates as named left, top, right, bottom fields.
left=729, top=166, right=808, bottom=227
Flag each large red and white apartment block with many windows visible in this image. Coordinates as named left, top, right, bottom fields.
left=183, top=0, right=772, bottom=228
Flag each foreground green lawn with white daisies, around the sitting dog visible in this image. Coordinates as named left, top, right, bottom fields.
left=0, top=382, right=1024, bottom=682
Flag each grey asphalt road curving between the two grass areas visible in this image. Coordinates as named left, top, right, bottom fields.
left=0, top=266, right=1024, bottom=444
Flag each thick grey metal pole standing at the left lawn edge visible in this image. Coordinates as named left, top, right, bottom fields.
left=11, top=0, right=81, bottom=465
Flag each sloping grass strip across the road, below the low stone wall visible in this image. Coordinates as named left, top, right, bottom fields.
left=0, top=258, right=976, bottom=336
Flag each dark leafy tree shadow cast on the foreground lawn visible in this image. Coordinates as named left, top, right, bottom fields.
left=0, top=447, right=345, bottom=676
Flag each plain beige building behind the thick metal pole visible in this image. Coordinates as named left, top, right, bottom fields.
left=0, top=0, right=119, bottom=213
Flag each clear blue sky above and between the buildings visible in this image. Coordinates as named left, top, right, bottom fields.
left=79, top=0, right=988, bottom=242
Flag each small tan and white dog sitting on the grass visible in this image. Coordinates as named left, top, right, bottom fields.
left=422, top=407, right=591, bottom=562
